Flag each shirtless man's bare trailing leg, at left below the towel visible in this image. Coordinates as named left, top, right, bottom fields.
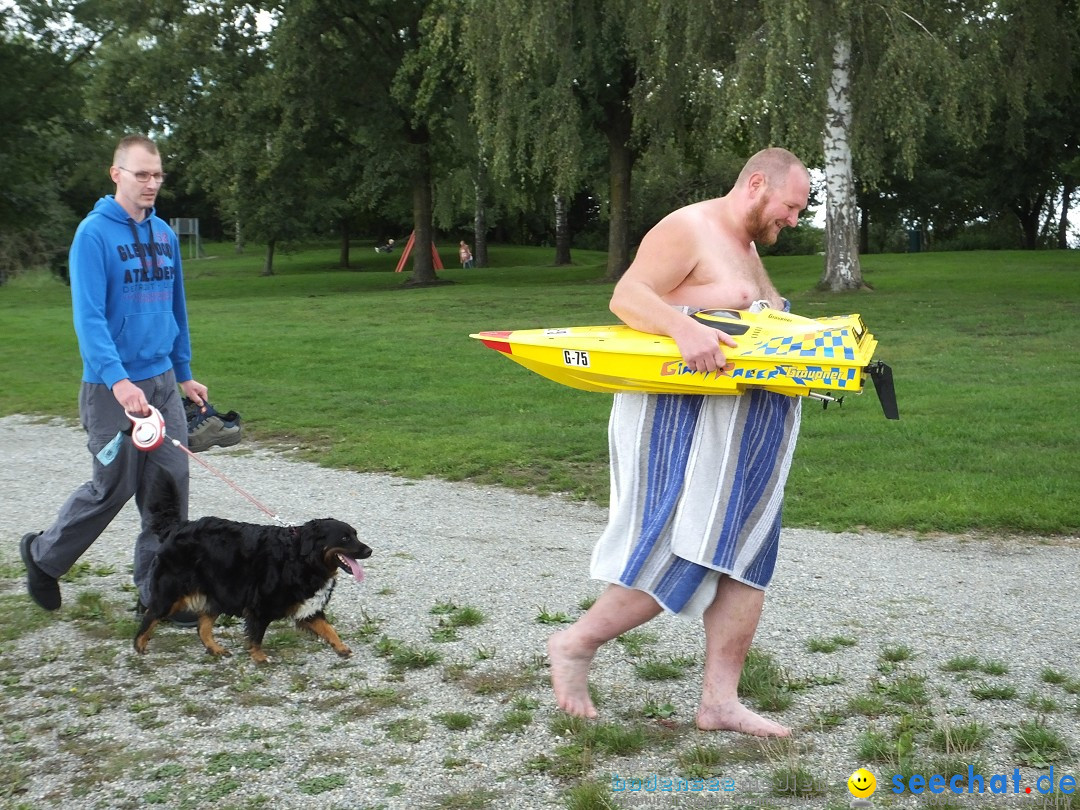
left=548, top=585, right=662, bottom=717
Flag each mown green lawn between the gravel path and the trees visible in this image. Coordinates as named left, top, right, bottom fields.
left=0, top=245, right=1080, bottom=535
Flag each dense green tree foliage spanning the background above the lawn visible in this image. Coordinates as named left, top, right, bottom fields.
left=0, top=0, right=1080, bottom=286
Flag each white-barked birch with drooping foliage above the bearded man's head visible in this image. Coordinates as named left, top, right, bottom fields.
left=721, top=0, right=993, bottom=291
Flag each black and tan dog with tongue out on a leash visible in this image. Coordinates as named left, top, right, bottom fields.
left=135, top=475, right=372, bottom=663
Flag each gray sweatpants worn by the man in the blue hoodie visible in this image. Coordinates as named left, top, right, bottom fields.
left=33, top=370, right=188, bottom=605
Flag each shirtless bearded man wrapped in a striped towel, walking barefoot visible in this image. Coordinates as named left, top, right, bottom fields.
left=548, top=148, right=810, bottom=737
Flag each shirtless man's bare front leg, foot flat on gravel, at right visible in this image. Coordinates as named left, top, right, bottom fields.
left=698, top=577, right=792, bottom=737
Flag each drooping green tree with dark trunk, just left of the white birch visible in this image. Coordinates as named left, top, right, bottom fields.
left=457, top=0, right=735, bottom=279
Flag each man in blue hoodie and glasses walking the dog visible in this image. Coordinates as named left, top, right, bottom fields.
left=19, top=135, right=206, bottom=610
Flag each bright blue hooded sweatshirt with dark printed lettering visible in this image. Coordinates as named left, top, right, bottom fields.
left=68, top=194, right=191, bottom=389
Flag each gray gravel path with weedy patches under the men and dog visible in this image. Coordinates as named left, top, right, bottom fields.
left=0, top=416, right=1080, bottom=808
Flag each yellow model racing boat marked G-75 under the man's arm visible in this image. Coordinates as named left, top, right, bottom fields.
left=470, top=309, right=900, bottom=419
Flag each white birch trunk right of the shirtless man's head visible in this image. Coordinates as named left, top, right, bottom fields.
left=818, top=33, right=863, bottom=293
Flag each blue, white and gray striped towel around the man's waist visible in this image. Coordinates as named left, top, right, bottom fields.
left=591, top=390, right=801, bottom=617
